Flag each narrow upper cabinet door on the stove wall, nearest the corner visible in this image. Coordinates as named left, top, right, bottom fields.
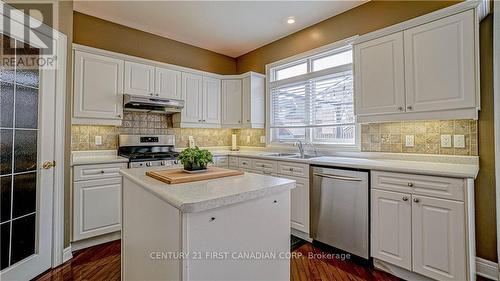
left=222, top=79, right=242, bottom=127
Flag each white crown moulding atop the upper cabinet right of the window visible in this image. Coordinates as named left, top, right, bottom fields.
left=353, top=0, right=481, bottom=44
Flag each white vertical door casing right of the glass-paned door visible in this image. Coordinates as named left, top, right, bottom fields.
left=52, top=32, right=70, bottom=267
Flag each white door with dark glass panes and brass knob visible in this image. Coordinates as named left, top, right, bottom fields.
left=0, top=34, right=56, bottom=280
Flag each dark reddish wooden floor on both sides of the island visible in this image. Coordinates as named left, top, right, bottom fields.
left=35, top=238, right=399, bottom=281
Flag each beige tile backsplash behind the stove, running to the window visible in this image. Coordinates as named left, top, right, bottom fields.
left=71, top=112, right=265, bottom=151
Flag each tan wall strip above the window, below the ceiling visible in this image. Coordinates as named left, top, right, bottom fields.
left=237, top=1, right=457, bottom=73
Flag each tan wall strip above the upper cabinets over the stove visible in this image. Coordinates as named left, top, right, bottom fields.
left=73, top=12, right=236, bottom=74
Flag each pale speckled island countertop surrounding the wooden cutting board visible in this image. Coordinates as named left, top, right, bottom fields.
left=120, top=168, right=295, bottom=213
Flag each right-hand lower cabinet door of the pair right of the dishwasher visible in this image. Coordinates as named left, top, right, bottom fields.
left=412, top=195, right=467, bottom=280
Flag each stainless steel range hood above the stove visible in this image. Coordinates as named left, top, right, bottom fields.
left=123, top=94, right=184, bottom=114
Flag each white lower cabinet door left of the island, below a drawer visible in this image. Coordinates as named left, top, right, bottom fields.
left=73, top=177, right=122, bottom=241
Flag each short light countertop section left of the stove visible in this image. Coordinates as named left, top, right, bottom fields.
left=71, top=150, right=128, bottom=166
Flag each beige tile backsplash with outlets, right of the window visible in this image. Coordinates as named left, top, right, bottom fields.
left=361, top=120, right=478, bottom=156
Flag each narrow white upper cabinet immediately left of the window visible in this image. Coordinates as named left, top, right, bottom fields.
left=242, top=73, right=265, bottom=129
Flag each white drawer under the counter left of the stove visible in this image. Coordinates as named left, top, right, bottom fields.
left=73, top=163, right=127, bottom=181
